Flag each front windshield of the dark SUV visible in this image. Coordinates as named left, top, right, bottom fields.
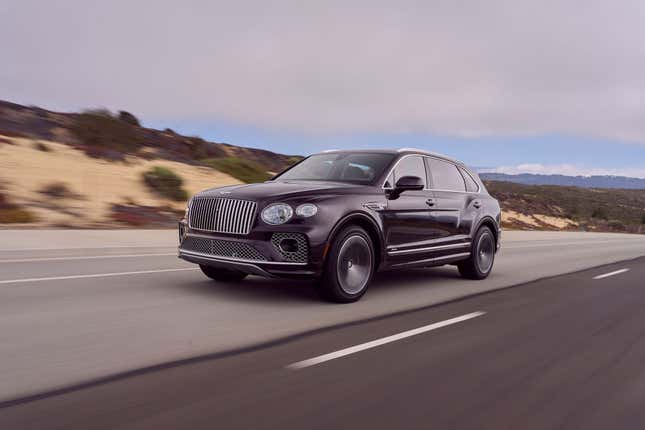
left=275, top=152, right=394, bottom=184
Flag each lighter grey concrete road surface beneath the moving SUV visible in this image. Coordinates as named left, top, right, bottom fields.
left=0, top=231, right=645, bottom=400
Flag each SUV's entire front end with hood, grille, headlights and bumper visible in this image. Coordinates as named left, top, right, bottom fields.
left=178, top=182, right=378, bottom=277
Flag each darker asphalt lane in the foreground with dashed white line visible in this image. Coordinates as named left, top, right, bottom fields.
left=0, top=258, right=645, bottom=430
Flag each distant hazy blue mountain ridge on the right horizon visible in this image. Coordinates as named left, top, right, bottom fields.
left=479, top=172, right=645, bottom=190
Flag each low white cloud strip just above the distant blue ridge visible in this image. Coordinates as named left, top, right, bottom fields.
left=486, top=164, right=645, bottom=178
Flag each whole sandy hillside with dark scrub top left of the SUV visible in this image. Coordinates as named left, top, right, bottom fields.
left=0, top=101, right=299, bottom=228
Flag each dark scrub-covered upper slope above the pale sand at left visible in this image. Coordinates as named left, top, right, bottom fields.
left=0, top=100, right=293, bottom=172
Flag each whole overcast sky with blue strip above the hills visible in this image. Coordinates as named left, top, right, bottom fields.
left=0, top=0, right=645, bottom=177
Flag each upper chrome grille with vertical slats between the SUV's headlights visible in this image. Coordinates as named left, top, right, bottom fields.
left=188, top=197, right=257, bottom=234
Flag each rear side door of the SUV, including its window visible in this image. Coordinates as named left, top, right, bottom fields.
left=426, top=157, right=475, bottom=244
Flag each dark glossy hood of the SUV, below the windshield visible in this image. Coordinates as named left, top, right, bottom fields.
left=198, top=181, right=362, bottom=201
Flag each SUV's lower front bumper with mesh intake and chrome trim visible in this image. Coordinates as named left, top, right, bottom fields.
left=178, top=222, right=322, bottom=278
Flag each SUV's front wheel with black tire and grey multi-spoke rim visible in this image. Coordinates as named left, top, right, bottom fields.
left=319, top=225, right=376, bottom=303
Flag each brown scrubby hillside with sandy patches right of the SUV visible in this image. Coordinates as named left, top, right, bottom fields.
left=485, top=181, right=645, bottom=233
